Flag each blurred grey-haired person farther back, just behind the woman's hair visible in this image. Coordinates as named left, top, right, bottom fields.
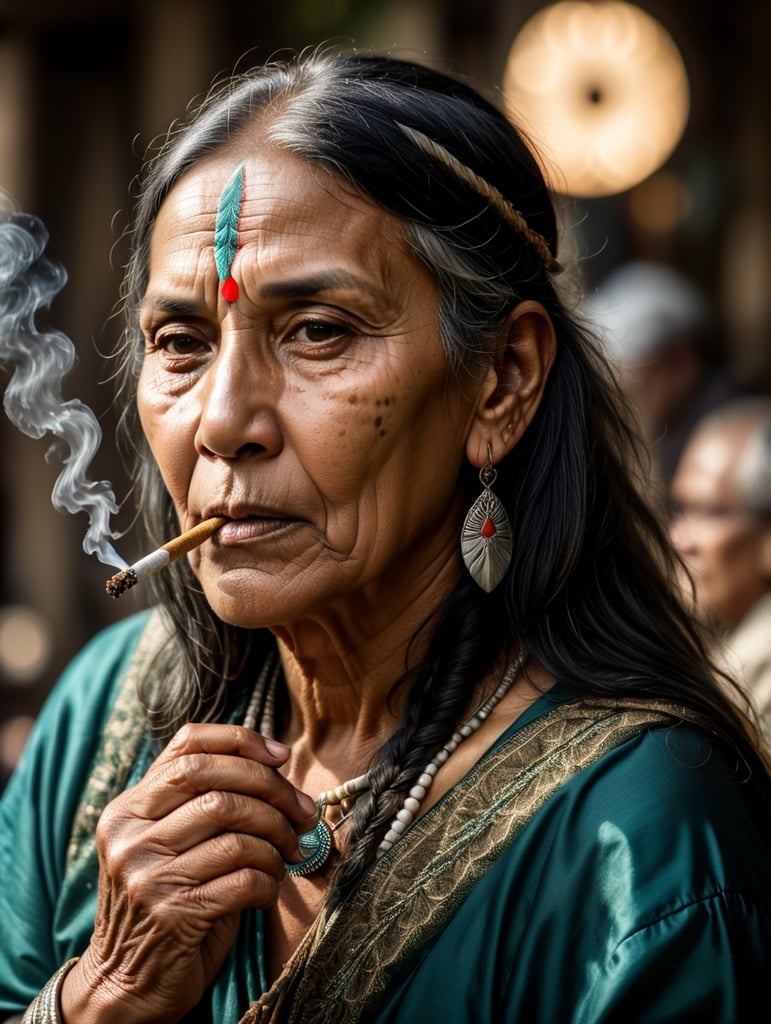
left=586, top=260, right=743, bottom=489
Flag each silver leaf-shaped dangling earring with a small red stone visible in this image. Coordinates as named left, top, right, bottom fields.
left=461, top=444, right=514, bottom=594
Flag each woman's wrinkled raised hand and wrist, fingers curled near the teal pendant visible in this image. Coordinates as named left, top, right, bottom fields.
left=56, top=725, right=316, bottom=1024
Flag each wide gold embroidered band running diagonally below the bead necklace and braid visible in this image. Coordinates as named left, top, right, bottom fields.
left=241, top=698, right=694, bottom=1024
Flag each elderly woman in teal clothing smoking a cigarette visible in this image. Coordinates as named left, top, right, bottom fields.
left=0, top=54, right=771, bottom=1024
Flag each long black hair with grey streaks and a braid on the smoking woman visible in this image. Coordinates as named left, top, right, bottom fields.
left=111, top=52, right=757, bottom=898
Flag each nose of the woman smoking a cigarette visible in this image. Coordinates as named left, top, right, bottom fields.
left=196, top=340, right=282, bottom=459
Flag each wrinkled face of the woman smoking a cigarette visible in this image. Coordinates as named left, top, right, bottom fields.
left=138, top=143, right=481, bottom=627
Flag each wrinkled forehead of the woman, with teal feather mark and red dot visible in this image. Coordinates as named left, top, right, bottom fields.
left=142, top=147, right=438, bottom=323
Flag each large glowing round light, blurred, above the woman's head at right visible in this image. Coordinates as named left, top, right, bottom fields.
left=503, top=0, right=690, bottom=198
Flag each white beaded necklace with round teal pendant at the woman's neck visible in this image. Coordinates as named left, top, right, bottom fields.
left=244, top=649, right=527, bottom=877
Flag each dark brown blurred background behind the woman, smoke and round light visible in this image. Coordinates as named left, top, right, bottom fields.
left=0, top=0, right=771, bottom=787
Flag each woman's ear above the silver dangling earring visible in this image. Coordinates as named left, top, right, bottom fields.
left=466, top=300, right=557, bottom=469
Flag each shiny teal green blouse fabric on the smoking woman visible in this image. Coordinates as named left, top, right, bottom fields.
left=0, top=613, right=771, bottom=1024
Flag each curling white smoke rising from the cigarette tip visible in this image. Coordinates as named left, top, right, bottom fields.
left=0, top=189, right=126, bottom=568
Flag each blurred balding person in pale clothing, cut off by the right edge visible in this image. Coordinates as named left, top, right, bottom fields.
left=671, top=397, right=771, bottom=742
